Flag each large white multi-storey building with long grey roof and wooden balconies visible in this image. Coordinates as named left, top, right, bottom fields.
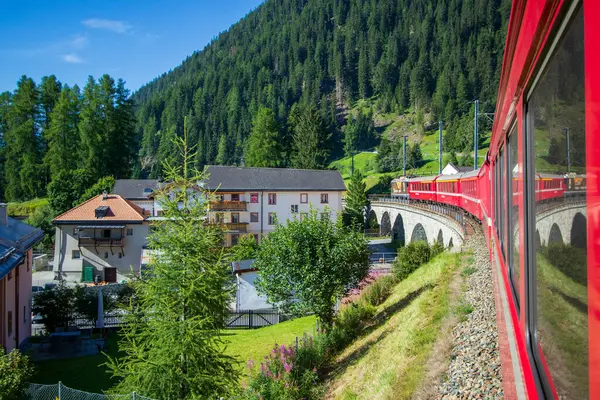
left=202, top=165, right=346, bottom=247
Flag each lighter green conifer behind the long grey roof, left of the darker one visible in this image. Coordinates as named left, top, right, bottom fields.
left=245, top=107, right=284, bottom=167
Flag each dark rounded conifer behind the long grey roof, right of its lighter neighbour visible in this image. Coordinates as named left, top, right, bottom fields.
left=292, top=106, right=331, bottom=169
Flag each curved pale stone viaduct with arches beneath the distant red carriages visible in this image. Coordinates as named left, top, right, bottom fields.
left=368, top=200, right=465, bottom=251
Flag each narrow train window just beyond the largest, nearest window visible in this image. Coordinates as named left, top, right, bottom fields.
left=507, top=126, right=522, bottom=304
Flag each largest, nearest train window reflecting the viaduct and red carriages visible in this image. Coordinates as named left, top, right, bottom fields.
left=527, top=7, right=591, bottom=399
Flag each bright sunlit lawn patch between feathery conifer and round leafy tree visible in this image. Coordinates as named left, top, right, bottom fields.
left=224, top=316, right=316, bottom=372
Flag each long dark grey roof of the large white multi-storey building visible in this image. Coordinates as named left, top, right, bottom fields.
left=206, top=165, right=346, bottom=191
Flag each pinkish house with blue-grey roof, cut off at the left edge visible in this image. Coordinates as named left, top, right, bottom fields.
left=0, top=203, right=44, bottom=351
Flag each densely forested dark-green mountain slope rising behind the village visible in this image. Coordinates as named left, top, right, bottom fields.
left=133, top=0, right=510, bottom=176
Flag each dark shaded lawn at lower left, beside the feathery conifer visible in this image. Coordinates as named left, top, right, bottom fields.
left=32, top=333, right=118, bottom=393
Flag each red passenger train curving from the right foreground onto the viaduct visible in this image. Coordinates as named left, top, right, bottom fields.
left=392, top=0, right=600, bottom=399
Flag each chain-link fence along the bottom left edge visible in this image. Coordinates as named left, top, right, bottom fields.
left=25, top=382, right=153, bottom=400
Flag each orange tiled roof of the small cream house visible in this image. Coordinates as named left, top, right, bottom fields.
left=52, top=194, right=145, bottom=223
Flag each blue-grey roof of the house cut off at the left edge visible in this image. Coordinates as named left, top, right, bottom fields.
left=0, top=217, right=44, bottom=279
